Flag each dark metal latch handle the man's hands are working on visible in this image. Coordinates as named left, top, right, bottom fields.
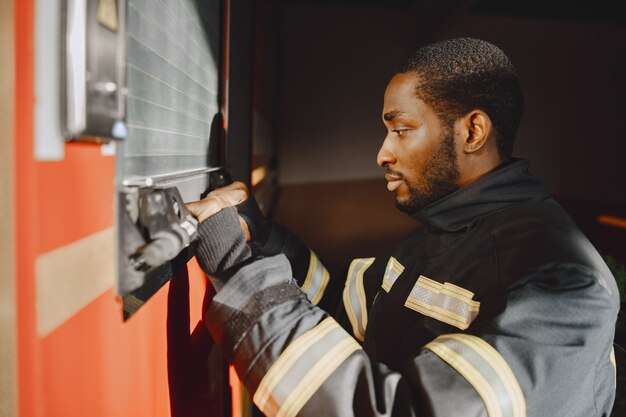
left=117, top=169, right=232, bottom=319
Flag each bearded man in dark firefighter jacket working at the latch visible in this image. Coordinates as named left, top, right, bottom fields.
left=189, top=38, right=619, bottom=417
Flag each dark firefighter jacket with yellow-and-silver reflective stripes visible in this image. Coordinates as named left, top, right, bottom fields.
left=198, top=160, right=619, bottom=417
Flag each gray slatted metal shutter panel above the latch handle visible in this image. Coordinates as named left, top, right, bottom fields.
left=118, top=0, right=221, bottom=184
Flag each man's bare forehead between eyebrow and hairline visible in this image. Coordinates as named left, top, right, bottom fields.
left=383, top=72, right=426, bottom=120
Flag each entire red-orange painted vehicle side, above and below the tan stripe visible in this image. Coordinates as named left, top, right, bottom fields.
left=15, top=0, right=210, bottom=417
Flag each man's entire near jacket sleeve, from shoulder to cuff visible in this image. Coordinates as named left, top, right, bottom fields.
left=204, top=249, right=616, bottom=417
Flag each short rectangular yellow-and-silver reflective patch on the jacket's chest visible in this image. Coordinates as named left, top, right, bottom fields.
left=404, top=275, right=480, bottom=330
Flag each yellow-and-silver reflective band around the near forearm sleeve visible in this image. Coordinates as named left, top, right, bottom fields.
left=253, top=318, right=361, bottom=417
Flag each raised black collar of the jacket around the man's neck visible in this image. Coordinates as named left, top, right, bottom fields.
left=411, top=159, right=550, bottom=232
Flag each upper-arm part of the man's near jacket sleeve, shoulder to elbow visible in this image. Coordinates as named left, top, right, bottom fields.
left=414, top=263, right=618, bottom=417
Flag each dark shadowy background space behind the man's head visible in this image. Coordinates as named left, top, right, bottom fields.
left=257, top=0, right=626, bottom=263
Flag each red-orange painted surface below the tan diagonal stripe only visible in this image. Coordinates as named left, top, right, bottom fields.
left=41, top=260, right=205, bottom=417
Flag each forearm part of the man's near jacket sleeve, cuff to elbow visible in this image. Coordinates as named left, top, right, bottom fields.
left=204, top=255, right=419, bottom=416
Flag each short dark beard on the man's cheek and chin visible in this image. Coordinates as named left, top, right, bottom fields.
left=396, top=128, right=459, bottom=215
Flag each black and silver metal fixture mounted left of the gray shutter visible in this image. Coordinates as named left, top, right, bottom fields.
left=61, top=0, right=126, bottom=142
